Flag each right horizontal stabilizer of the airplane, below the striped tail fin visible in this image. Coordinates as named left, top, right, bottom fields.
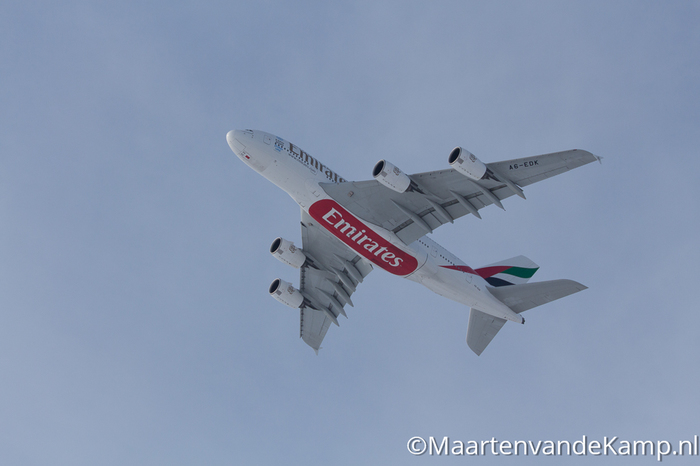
left=489, top=280, right=588, bottom=313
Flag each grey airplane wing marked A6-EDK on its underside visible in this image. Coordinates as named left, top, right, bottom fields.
left=321, top=150, right=599, bottom=244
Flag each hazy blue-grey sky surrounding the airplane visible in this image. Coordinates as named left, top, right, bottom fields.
left=0, top=0, right=700, bottom=466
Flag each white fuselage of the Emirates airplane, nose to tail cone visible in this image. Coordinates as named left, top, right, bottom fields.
left=226, top=130, right=522, bottom=323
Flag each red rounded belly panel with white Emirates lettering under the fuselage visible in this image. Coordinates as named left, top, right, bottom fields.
left=309, top=199, right=418, bottom=276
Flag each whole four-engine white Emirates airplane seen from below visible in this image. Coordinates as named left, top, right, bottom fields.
left=226, top=129, right=601, bottom=355
